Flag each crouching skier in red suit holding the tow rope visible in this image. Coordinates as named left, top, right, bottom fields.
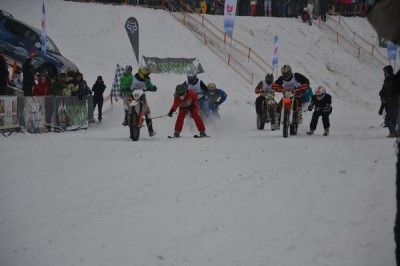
left=168, top=84, right=207, bottom=138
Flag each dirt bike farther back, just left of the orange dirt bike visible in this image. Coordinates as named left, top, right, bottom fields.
left=256, top=92, right=278, bottom=130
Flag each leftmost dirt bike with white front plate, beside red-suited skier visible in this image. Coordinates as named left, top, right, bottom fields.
left=128, top=90, right=147, bottom=141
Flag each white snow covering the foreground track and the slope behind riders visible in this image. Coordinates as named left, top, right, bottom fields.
left=0, top=0, right=396, bottom=266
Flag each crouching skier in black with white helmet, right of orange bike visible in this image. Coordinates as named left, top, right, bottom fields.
left=307, top=86, right=332, bottom=136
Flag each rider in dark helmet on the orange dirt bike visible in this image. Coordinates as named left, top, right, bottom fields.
left=271, top=65, right=310, bottom=129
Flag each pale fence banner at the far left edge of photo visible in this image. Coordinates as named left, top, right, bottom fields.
left=0, top=96, right=19, bottom=130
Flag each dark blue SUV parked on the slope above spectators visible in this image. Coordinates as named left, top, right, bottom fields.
left=0, top=10, right=78, bottom=76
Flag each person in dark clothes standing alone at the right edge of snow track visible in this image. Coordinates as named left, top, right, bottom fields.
left=379, top=65, right=400, bottom=138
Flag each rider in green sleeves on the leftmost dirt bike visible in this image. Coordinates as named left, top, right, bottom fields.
left=124, top=67, right=157, bottom=137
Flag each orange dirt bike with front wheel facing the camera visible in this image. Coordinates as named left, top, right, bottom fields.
left=280, top=88, right=299, bottom=138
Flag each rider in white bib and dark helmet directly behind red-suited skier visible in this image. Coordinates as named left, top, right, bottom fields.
left=183, top=72, right=210, bottom=118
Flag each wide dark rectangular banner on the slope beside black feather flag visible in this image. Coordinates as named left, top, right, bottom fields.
left=143, top=56, right=204, bottom=74
